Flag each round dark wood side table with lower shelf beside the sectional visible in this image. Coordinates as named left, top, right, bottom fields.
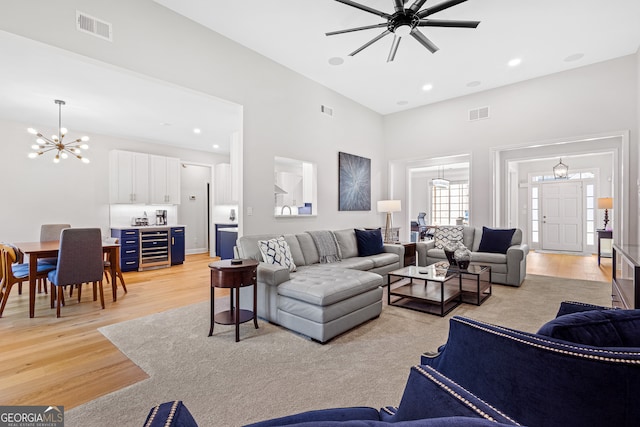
left=209, top=259, right=258, bottom=342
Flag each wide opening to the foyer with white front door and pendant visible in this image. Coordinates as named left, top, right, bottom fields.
left=493, top=132, right=634, bottom=254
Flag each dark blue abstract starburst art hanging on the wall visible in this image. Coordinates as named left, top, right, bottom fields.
left=338, top=152, right=371, bottom=211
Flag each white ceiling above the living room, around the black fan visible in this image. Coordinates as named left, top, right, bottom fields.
left=154, top=0, right=640, bottom=114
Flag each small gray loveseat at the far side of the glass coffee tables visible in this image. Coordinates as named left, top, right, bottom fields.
left=416, top=226, right=529, bottom=286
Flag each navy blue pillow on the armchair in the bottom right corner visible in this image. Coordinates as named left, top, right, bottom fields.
left=538, top=310, right=640, bottom=347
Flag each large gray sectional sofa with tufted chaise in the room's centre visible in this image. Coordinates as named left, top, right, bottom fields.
left=236, top=229, right=404, bottom=342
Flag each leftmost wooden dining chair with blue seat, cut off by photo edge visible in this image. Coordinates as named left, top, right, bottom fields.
left=0, top=243, right=55, bottom=317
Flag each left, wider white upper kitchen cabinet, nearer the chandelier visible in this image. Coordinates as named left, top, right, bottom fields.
left=109, top=150, right=149, bottom=204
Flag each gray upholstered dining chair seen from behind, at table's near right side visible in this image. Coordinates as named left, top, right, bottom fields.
left=48, top=228, right=104, bottom=317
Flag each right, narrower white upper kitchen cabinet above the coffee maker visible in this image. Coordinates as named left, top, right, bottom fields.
left=149, top=155, right=180, bottom=205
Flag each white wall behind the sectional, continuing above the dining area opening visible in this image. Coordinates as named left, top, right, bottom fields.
left=0, top=0, right=387, bottom=234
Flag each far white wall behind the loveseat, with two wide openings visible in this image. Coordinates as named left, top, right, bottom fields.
left=384, top=55, right=639, bottom=243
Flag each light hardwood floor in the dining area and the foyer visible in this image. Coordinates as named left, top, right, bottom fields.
left=0, top=252, right=611, bottom=409
